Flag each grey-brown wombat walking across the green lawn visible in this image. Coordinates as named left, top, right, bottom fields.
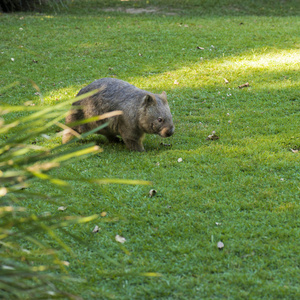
left=63, top=78, right=174, bottom=151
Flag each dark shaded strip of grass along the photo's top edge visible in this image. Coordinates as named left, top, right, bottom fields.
left=70, top=0, right=300, bottom=17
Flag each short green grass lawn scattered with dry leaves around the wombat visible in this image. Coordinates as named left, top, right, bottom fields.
left=0, top=0, right=300, bottom=299
